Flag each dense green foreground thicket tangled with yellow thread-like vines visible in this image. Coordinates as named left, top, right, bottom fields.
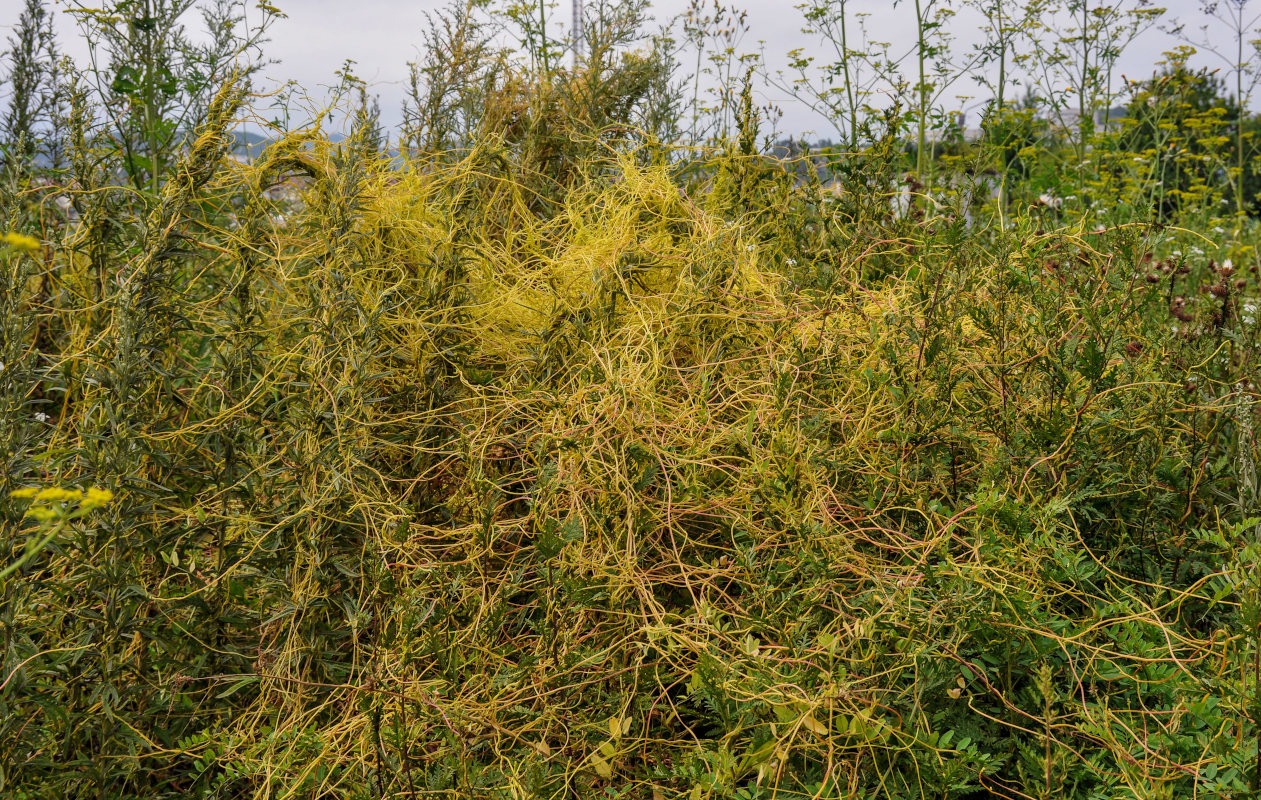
left=0, top=118, right=1255, bottom=799
